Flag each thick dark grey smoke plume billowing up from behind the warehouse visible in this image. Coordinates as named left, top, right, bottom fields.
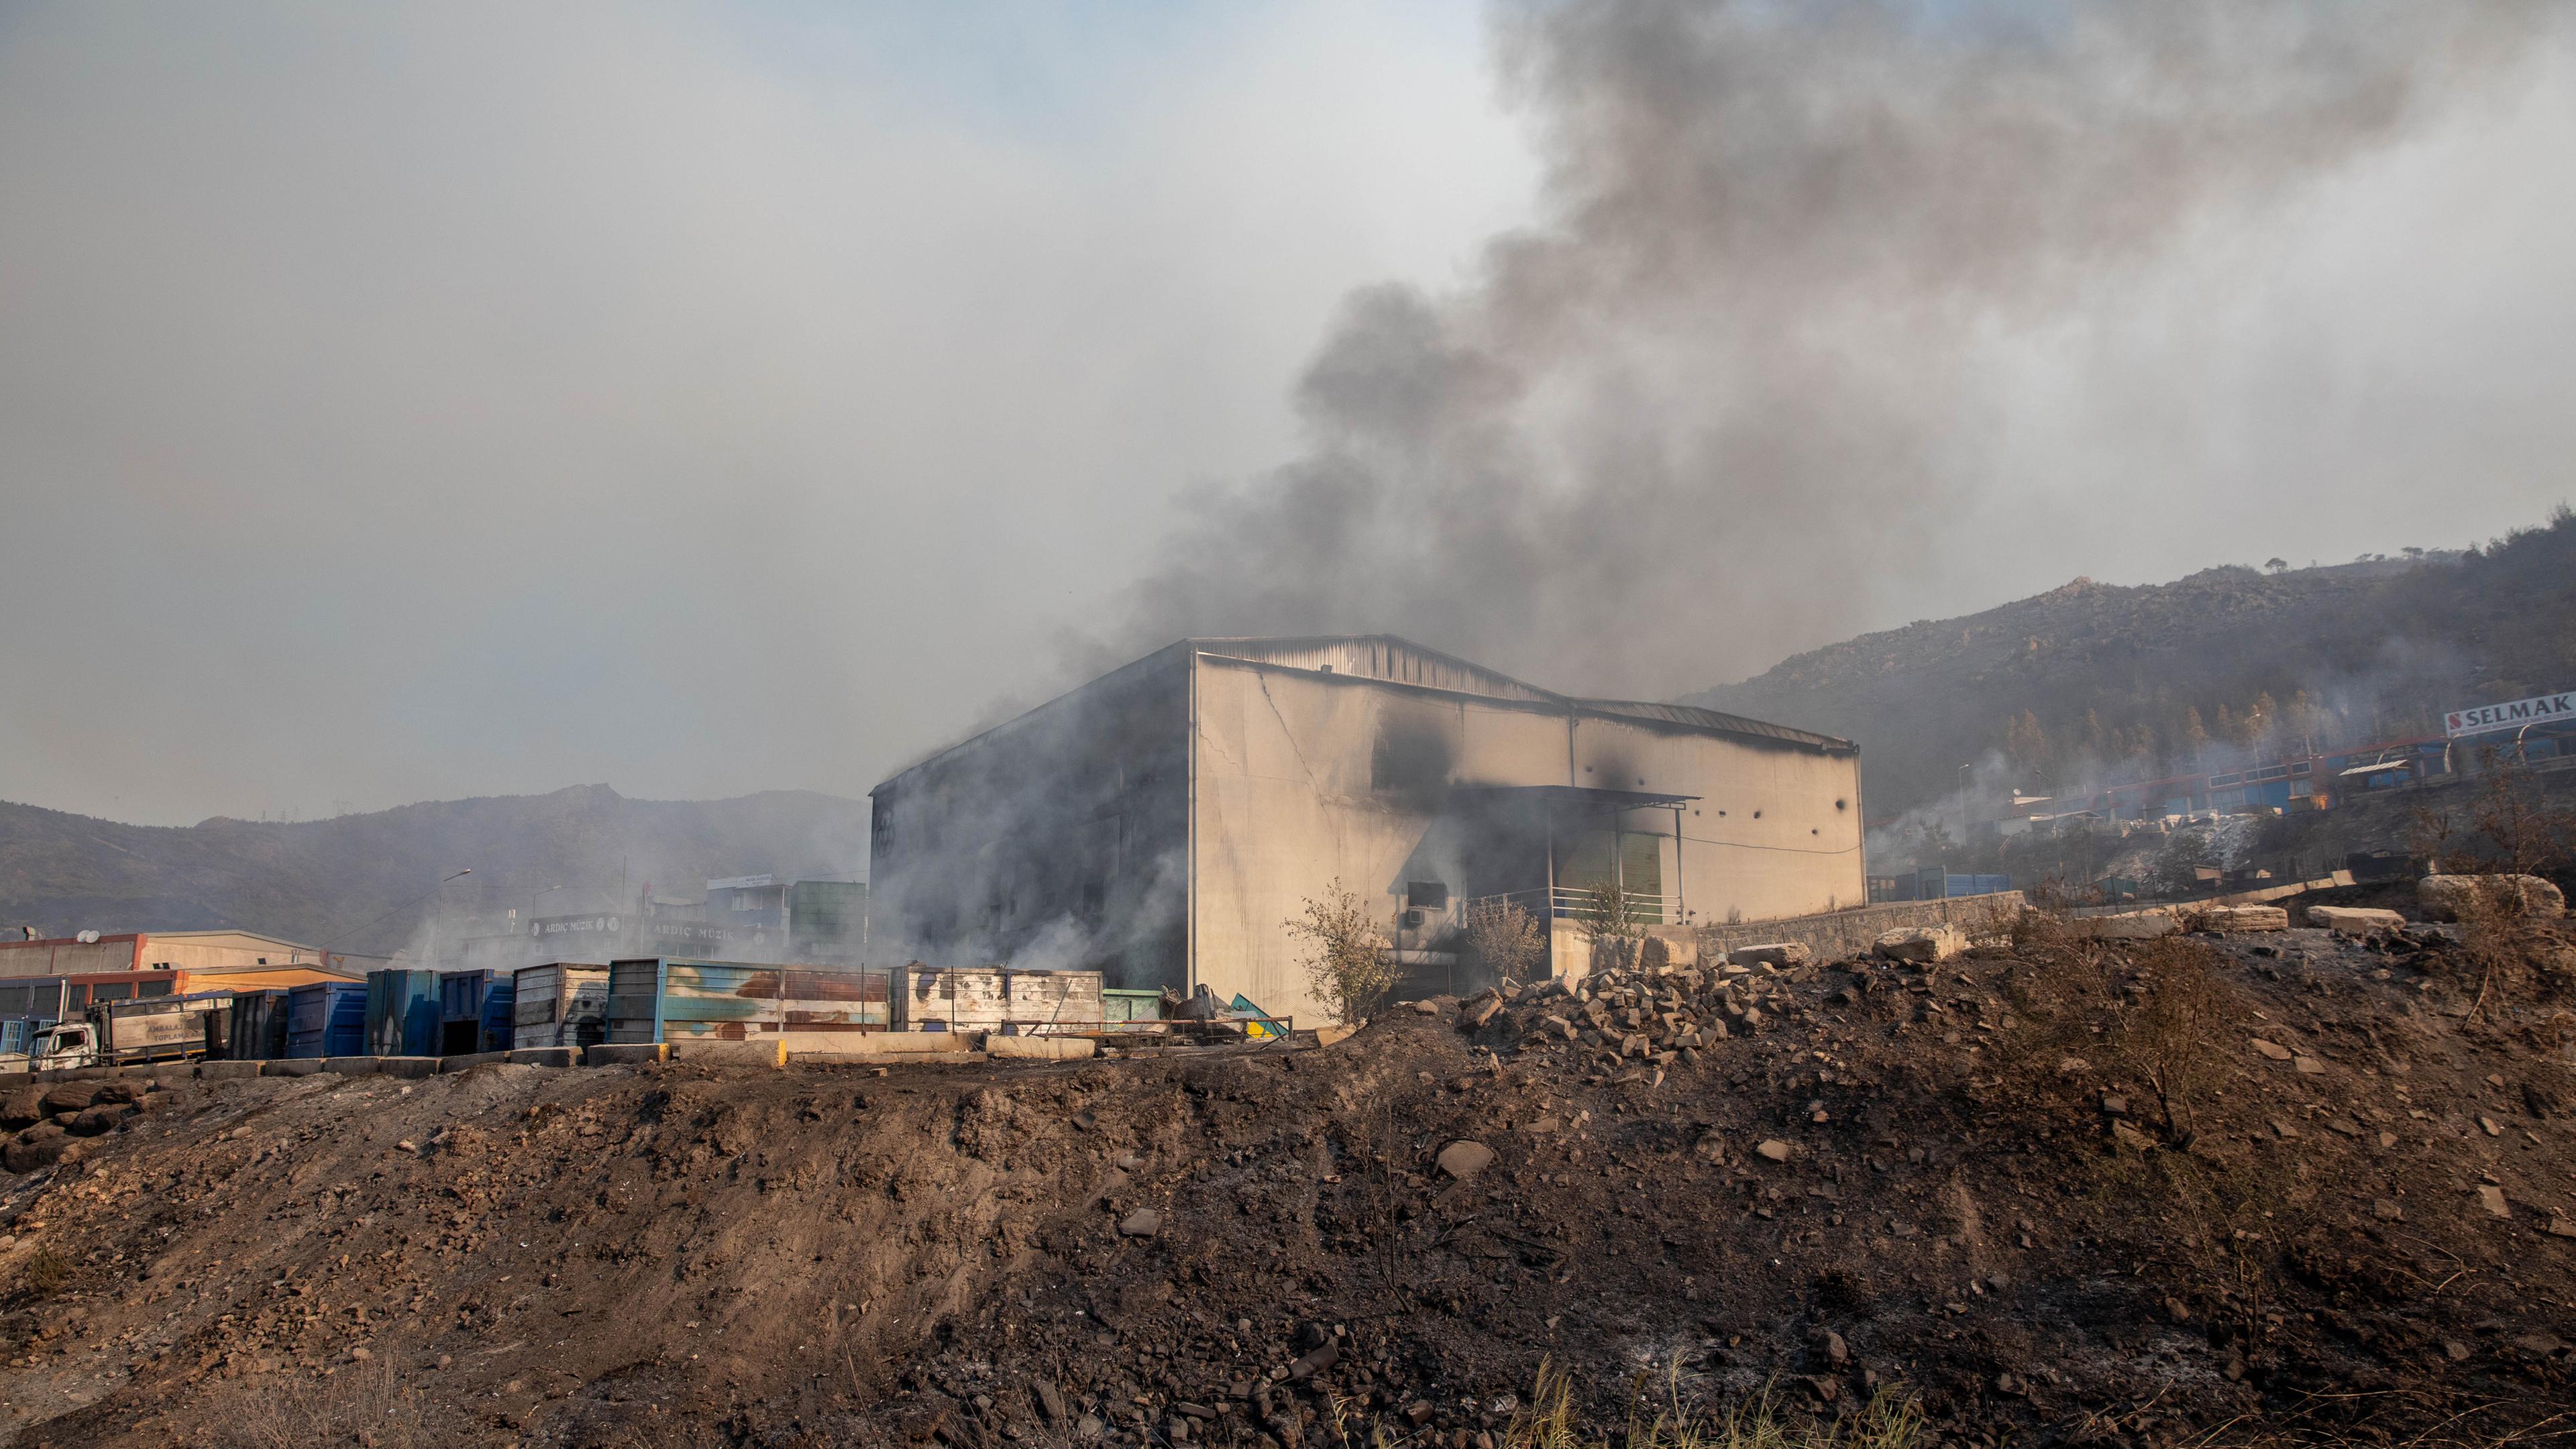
left=1128, top=0, right=2555, bottom=694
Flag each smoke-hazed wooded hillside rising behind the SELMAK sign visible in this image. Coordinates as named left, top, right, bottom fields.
left=1684, top=508, right=2576, bottom=820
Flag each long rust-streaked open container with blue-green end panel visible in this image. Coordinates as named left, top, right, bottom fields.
left=608, top=957, right=889, bottom=1042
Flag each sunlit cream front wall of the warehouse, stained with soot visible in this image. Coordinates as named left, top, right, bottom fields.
left=1190, top=657, right=1868, bottom=1024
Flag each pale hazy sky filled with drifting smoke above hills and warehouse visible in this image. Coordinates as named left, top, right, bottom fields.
left=0, top=0, right=2576, bottom=822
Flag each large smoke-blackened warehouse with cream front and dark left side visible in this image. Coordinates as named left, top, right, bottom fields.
left=868, top=634, right=1868, bottom=1021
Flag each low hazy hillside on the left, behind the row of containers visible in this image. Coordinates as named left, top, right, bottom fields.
left=0, top=784, right=868, bottom=954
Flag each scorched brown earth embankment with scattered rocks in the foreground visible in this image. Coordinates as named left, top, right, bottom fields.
left=0, top=930, right=2576, bottom=1449
